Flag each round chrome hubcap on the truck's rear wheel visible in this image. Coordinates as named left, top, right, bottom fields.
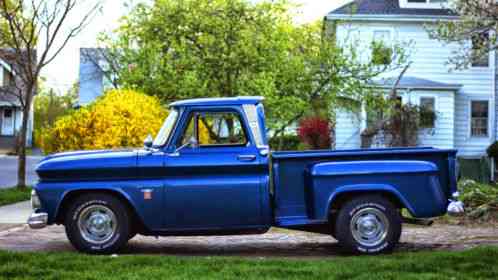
left=350, top=208, right=389, bottom=247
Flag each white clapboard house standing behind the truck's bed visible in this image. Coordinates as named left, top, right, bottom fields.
left=326, top=0, right=497, bottom=164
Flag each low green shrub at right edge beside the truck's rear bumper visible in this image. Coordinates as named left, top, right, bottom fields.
left=458, top=180, right=498, bottom=221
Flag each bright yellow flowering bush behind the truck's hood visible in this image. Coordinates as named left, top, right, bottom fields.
left=40, top=90, right=167, bottom=153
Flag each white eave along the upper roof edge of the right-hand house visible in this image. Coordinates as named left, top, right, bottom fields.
left=325, top=14, right=459, bottom=22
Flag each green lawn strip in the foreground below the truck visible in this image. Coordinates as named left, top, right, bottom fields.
left=0, top=247, right=498, bottom=279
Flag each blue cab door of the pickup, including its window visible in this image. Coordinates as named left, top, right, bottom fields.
left=164, top=111, right=267, bottom=230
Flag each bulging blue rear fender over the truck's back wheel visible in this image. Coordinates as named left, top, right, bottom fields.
left=307, top=160, right=447, bottom=220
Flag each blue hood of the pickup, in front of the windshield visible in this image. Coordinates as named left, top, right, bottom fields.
left=36, top=150, right=139, bottom=181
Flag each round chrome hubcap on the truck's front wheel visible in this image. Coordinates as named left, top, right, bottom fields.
left=78, top=205, right=117, bottom=244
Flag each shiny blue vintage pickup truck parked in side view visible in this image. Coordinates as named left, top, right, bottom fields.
left=28, top=97, right=463, bottom=254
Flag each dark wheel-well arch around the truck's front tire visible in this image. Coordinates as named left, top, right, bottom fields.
left=55, top=189, right=146, bottom=232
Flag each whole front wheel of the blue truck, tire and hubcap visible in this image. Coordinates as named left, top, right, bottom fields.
left=64, top=193, right=130, bottom=254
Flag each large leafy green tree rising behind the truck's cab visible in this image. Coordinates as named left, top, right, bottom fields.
left=103, top=0, right=405, bottom=139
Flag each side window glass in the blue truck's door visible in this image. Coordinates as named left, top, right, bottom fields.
left=179, top=112, right=248, bottom=147
